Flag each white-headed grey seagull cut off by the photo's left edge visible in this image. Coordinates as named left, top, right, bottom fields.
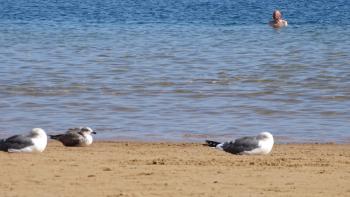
left=0, top=128, right=47, bottom=153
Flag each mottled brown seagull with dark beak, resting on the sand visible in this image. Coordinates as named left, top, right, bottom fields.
left=49, top=127, right=96, bottom=146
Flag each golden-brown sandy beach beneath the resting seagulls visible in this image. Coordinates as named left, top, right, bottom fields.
left=0, top=142, right=350, bottom=197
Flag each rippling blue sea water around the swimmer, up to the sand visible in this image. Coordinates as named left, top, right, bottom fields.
left=0, top=0, right=350, bottom=143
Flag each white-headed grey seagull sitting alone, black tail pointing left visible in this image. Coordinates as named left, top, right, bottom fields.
left=206, top=132, right=274, bottom=155
